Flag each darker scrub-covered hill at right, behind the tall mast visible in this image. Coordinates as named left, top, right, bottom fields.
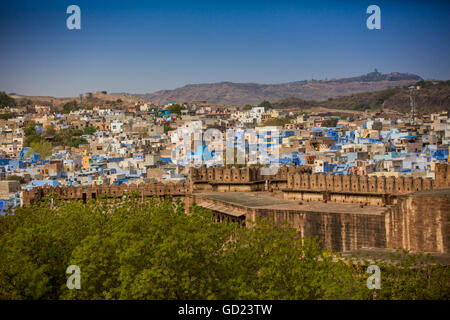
left=272, top=80, right=450, bottom=113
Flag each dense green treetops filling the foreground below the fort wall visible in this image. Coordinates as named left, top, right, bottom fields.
left=0, top=194, right=449, bottom=299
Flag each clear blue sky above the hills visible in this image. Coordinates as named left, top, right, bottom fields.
left=0, top=0, right=450, bottom=96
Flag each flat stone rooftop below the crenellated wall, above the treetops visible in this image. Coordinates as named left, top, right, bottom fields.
left=196, top=192, right=387, bottom=215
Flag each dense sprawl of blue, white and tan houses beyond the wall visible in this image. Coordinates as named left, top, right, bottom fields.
left=0, top=95, right=450, bottom=214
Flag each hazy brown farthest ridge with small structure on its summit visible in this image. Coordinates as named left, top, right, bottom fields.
left=137, top=72, right=422, bottom=106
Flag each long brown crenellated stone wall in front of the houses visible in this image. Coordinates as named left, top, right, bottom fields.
left=23, top=164, right=450, bottom=205
